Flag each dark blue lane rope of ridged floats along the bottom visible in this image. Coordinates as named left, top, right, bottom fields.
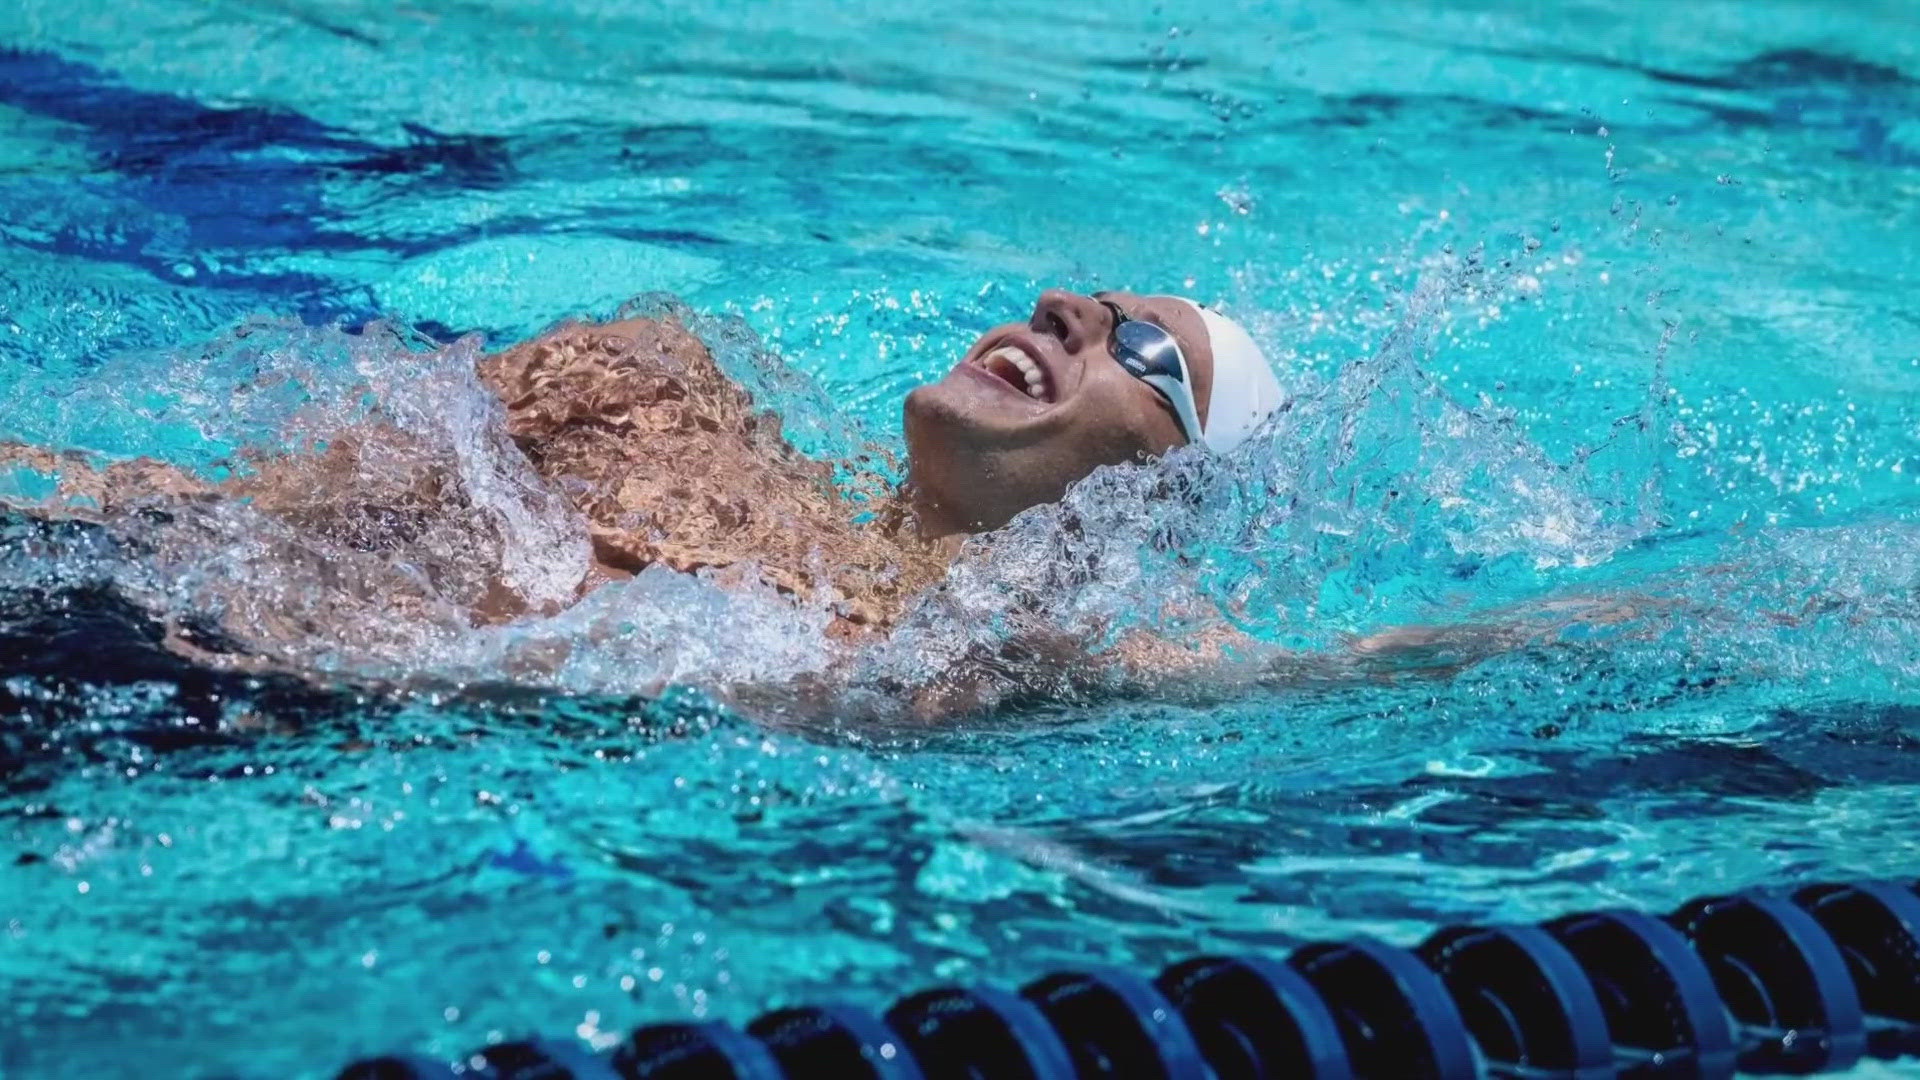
left=340, top=882, right=1920, bottom=1080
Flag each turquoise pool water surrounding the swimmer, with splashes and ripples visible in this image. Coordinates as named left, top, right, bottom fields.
left=0, top=0, right=1920, bottom=1076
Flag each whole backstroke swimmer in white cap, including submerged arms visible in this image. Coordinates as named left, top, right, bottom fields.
left=0, top=288, right=1589, bottom=717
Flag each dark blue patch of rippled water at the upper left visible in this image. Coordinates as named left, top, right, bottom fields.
left=0, top=48, right=668, bottom=363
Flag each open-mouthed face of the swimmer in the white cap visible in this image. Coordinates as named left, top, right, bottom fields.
left=906, top=288, right=1213, bottom=536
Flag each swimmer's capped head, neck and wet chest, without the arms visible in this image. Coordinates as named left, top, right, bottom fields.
left=480, top=290, right=1281, bottom=634
